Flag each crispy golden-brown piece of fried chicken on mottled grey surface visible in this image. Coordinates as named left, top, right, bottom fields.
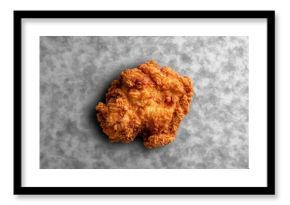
left=96, top=61, right=194, bottom=148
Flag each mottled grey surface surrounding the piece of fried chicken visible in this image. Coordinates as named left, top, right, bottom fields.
left=40, top=37, right=249, bottom=169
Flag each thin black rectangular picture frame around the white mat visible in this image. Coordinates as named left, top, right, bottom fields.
left=14, top=11, right=275, bottom=195
